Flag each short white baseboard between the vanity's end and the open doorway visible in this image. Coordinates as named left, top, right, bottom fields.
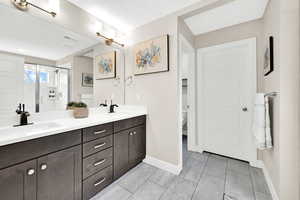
left=143, top=156, right=182, bottom=175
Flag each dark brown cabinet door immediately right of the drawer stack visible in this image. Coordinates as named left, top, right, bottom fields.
left=114, top=130, right=129, bottom=180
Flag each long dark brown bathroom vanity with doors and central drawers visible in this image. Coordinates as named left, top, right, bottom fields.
left=0, top=115, right=146, bottom=200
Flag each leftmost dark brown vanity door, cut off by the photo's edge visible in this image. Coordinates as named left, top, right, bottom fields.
left=0, top=160, right=36, bottom=200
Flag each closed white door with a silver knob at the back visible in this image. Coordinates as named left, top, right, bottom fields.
left=197, top=38, right=256, bottom=162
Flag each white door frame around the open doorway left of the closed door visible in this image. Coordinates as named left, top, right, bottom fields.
left=178, top=34, right=197, bottom=164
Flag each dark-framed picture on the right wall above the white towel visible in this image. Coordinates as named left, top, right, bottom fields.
left=264, top=36, right=274, bottom=76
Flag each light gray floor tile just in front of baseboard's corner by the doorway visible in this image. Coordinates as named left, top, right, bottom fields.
left=149, top=169, right=176, bottom=188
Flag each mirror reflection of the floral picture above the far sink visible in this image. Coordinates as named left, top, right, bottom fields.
left=95, top=51, right=116, bottom=80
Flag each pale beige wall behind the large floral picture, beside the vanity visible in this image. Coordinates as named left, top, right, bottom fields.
left=126, top=15, right=181, bottom=166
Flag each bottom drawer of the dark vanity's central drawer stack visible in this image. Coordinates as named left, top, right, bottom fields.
left=83, top=166, right=113, bottom=200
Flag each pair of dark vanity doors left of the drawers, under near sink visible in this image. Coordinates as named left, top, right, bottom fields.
left=0, top=146, right=81, bottom=200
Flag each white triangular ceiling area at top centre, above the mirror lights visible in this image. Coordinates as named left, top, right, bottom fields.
left=64, top=0, right=202, bottom=33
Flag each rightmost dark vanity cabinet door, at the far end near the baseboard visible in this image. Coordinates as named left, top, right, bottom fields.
left=129, top=126, right=146, bottom=167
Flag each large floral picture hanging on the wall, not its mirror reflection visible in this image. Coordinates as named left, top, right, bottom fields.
left=133, top=35, right=169, bottom=75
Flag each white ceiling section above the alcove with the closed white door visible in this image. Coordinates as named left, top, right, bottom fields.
left=185, top=0, right=269, bottom=35
